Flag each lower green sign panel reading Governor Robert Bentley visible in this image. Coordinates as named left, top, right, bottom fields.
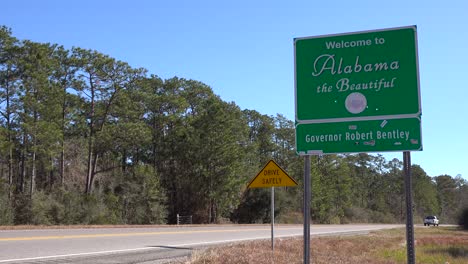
left=296, top=117, right=422, bottom=155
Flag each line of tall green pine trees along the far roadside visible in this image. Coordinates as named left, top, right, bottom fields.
left=0, top=27, right=468, bottom=225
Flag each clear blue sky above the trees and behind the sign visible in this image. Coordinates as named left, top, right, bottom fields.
left=0, top=0, right=468, bottom=179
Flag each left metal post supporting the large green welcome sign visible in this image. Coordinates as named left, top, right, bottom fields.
left=304, top=155, right=311, bottom=264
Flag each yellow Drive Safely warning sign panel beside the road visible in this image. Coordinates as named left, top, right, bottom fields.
left=247, top=160, right=297, bottom=188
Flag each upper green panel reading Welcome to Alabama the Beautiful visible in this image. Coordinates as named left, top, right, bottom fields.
left=294, top=26, right=421, bottom=123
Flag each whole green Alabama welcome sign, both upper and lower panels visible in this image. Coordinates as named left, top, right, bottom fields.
left=294, top=26, right=422, bottom=155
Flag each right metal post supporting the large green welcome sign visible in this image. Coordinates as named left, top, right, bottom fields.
left=403, top=151, right=415, bottom=264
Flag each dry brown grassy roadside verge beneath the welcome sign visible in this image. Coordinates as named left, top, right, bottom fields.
left=174, top=227, right=468, bottom=264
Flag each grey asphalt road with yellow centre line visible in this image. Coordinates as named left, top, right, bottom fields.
left=0, top=225, right=404, bottom=264
